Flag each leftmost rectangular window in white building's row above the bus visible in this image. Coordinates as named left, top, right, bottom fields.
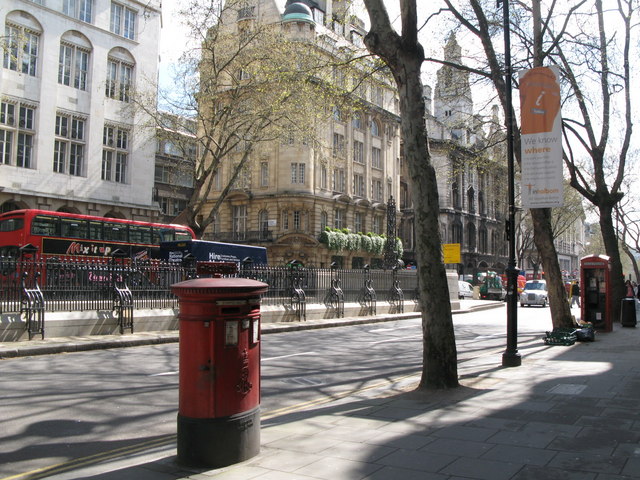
left=0, top=102, right=35, bottom=168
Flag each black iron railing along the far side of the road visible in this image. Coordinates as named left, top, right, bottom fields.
left=0, top=257, right=417, bottom=316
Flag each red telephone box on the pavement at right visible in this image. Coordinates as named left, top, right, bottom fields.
left=580, top=255, right=613, bottom=332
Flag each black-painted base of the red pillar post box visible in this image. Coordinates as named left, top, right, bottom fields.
left=178, top=407, right=260, bottom=468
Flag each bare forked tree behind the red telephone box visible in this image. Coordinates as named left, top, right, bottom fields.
left=550, top=0, right=640, bottom=319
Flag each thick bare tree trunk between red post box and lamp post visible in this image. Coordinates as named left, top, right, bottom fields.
left=364, top=0, right=458, bottom=389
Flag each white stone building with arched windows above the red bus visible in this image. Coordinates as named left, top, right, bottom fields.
left=0, top=0, right=160, bottom=219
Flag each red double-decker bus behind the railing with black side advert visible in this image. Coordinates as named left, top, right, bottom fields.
left=0, top=210, right=195, bottom=259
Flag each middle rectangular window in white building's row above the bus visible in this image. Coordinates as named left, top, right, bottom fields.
left=53, top=114, right=86, bottom=177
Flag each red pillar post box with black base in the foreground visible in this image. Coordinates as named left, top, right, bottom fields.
left=171, top=264, right=268, bottom=468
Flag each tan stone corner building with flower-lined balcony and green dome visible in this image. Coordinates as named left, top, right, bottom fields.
left=203, top=0, right=400, bottom=268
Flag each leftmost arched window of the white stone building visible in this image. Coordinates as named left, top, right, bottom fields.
left=2, top=25, right=40, bottom=77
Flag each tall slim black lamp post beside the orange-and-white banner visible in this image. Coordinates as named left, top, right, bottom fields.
left=498, top=0, right=522, bottom=367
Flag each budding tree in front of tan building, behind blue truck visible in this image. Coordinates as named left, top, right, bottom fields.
left=138, top=0, right=376, bottom=237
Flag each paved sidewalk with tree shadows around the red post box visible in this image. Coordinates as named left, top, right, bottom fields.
left=166, top=316, right=640, bottom=480
